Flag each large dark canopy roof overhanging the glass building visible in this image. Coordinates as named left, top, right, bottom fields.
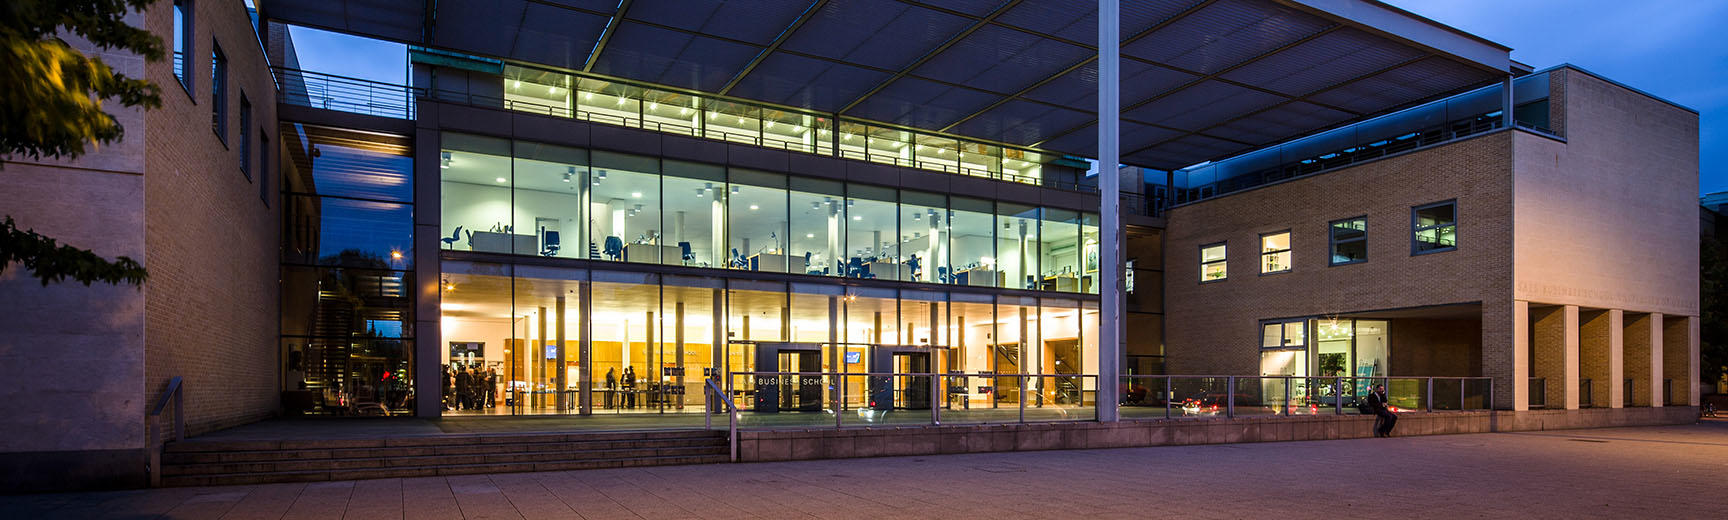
left=264, top=0, right=1510, bottom=169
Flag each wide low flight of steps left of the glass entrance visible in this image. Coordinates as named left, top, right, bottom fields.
left=162, top=430, right=729, bottom=485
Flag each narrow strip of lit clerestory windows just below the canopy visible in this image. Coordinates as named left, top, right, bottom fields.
left=415, top=52, right=1080, bottom=190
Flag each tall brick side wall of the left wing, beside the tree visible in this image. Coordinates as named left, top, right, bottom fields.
left=142, top=2, right=280, bottom=432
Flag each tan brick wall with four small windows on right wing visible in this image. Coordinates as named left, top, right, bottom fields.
left=1165, top=131, right=1512, bottom=377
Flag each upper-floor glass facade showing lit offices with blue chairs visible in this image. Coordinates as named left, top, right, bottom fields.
left=439, top=131, right=1099, bottom=294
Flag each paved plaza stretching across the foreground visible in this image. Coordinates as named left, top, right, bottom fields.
left=0, top=416, right=1728, bottom=520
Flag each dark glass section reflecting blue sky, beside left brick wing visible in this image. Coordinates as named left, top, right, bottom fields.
left=278, top=123, right=415, bottom=415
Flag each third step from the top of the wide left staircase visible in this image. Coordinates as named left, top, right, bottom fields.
left=162, top=444, right=727, bottom=477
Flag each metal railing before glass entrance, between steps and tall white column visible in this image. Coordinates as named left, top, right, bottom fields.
left=726, top=371, right=1097, bottom=428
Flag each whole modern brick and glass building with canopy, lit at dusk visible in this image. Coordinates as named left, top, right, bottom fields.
left=0, top=0, right=1699, bottom=489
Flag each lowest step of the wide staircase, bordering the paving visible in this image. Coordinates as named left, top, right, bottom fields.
left=162, top=454, right=727, bottom=485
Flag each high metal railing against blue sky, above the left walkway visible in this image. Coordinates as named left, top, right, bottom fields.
left=270, top=67, right=416, bottom=119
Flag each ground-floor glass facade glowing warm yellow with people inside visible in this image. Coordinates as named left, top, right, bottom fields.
left=439, top=259, right=1097, bottom=414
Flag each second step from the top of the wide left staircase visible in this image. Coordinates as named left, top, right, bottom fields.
left=162, top=435, right=726, bottom=465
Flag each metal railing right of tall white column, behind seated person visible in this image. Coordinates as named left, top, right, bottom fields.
left=1118, top=375, right=1493, bottom=420
